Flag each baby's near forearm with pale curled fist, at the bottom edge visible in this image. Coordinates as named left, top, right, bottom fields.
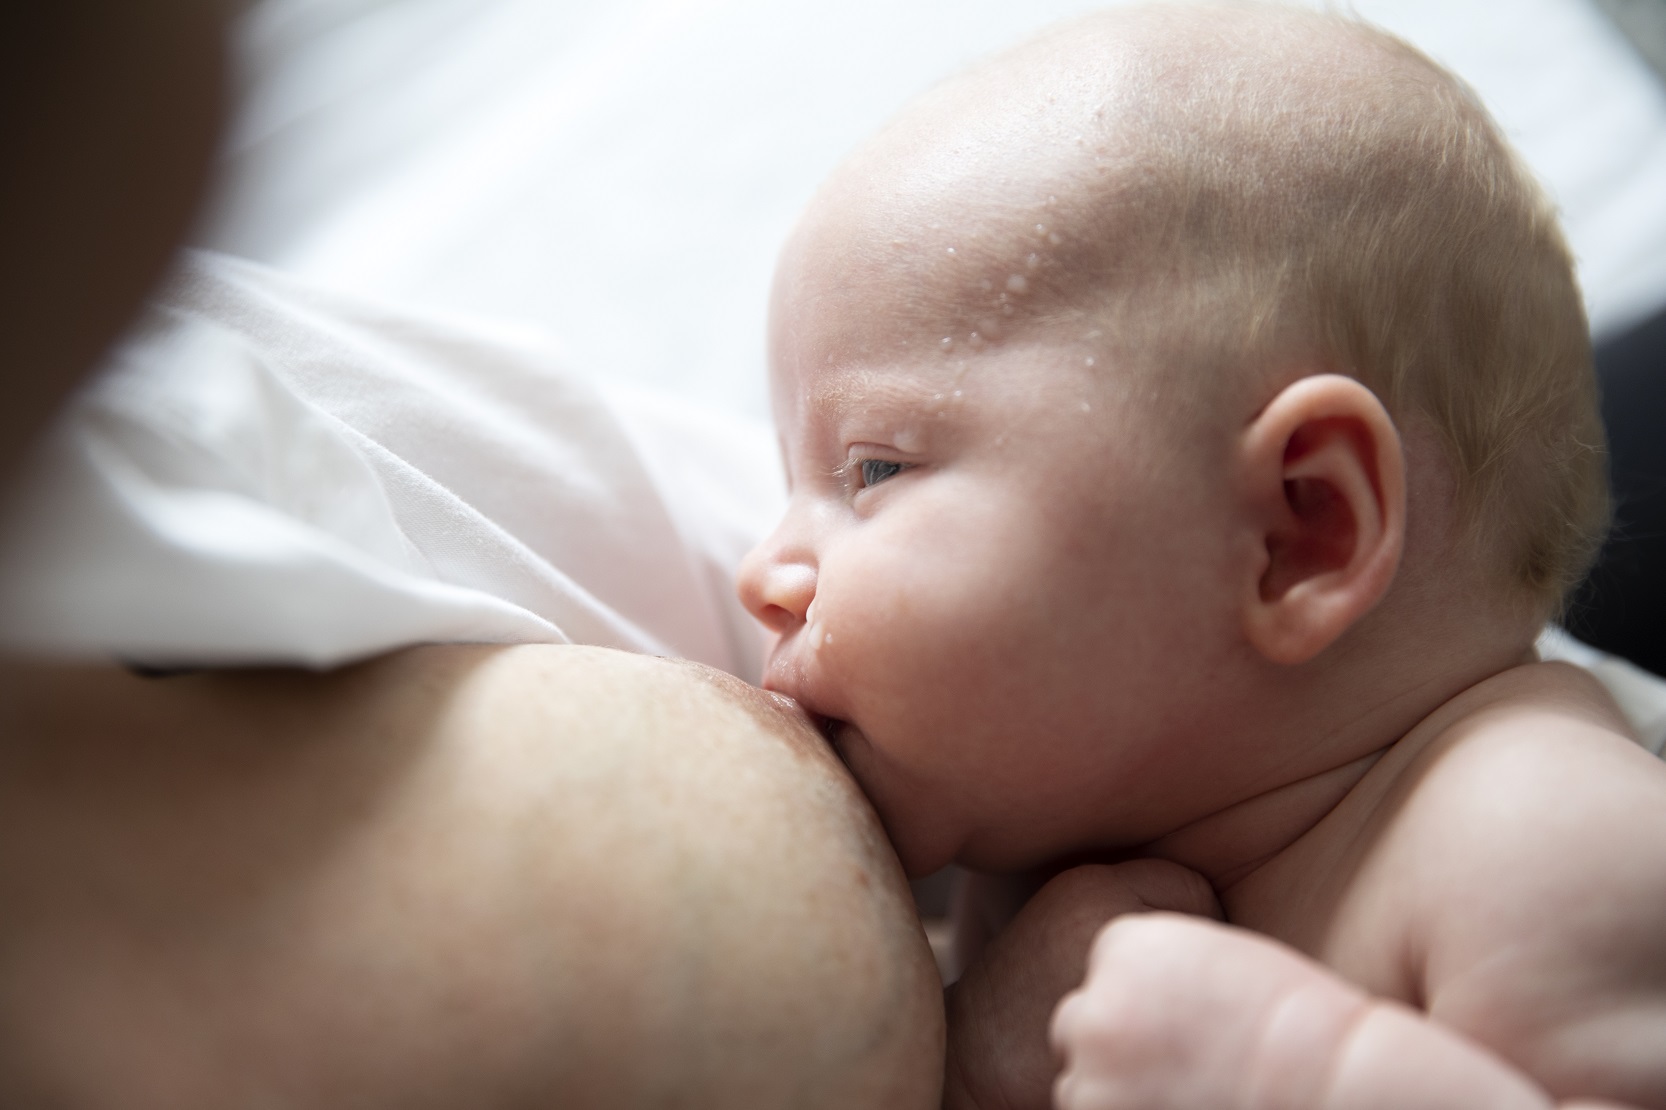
left=1053, top=913, right=1639, bottom=1110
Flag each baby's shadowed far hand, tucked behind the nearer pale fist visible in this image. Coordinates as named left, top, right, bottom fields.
left=943, top=860, right=1220, bottom=1110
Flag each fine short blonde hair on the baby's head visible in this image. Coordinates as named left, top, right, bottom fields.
left=1036, top=3, right=1609, bottom=615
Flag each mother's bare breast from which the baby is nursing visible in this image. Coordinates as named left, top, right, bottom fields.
left=0, top=647, right=943, bottom=1110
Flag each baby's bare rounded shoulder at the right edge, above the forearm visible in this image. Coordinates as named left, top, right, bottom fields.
left=1379, top=663, right=1666, bottom=1082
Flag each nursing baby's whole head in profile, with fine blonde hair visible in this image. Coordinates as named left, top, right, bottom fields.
left=741, top=7, right=1606, bottom=873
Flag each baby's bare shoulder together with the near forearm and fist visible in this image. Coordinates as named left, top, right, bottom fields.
left=1032, top=663, right=1666, bottom=1110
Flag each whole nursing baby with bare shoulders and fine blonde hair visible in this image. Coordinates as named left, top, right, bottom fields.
left=740, top=5, right=1666, bottom=1110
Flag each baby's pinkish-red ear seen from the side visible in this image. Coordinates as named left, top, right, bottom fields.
left=1238, top=373, right=1406, bottom=663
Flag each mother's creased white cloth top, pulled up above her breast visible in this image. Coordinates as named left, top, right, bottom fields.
left=0, top=255, right=780, bottom=677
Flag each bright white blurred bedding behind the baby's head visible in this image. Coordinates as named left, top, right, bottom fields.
left=197, top=0, right=1666, bottom=418
